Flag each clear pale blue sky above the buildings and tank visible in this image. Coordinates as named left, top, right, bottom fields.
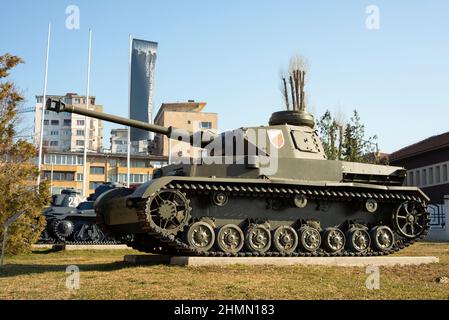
left=0, top=0, right=449, bottom=152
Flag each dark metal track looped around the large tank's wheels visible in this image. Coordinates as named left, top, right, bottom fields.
left=131, top=183, right=430, bottom=257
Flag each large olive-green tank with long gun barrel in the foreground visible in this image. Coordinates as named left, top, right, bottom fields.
left=46, top=99, right=430, bottom=257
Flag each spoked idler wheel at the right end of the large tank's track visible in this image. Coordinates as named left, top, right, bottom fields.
left=393, top=200, right=428, bottom=239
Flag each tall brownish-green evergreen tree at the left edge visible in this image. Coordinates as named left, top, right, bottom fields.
left=0, top=54, right=50, bottom=254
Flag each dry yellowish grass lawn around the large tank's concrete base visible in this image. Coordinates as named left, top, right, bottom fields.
left=0, top=243, right=449, bottom=300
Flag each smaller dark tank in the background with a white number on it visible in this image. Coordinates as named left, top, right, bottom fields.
left=39, top=183, right=123, bottom=244
